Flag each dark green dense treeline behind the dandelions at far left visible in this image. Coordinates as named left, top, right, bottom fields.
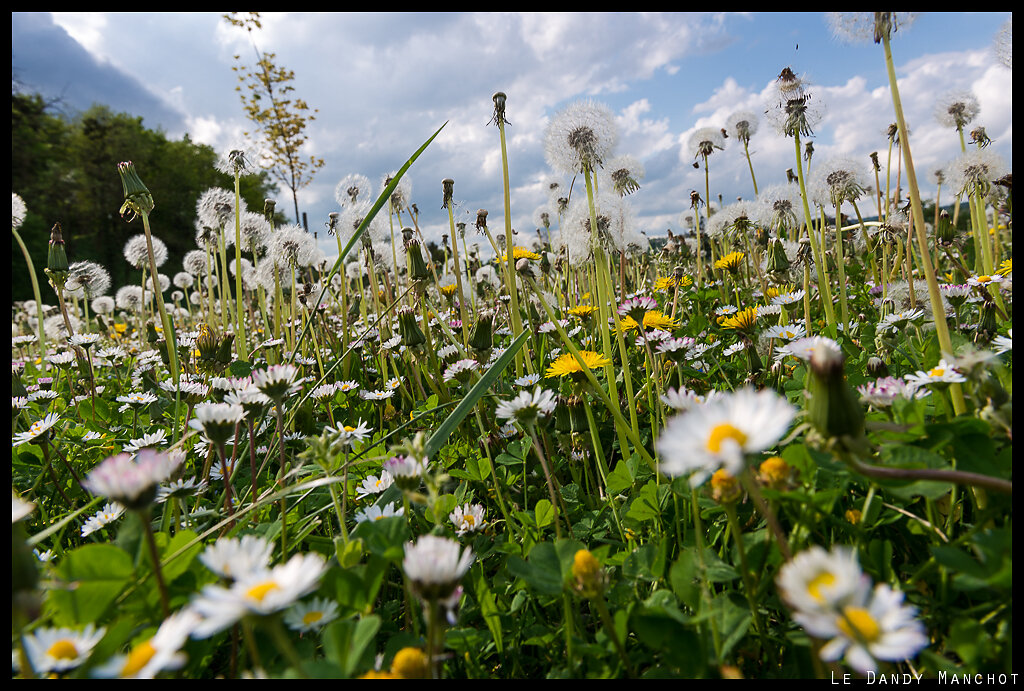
left=10, top=93, right=276, bottom=304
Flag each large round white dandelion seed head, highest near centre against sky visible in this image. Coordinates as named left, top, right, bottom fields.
left=544, top=100, right=618, bottom=175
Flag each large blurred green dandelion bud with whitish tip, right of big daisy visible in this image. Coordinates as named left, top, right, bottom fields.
left=807, top=343, right=864, bottom=439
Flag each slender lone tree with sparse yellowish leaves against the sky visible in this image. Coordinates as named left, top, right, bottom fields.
left=224, top=12, right=324, bottom=223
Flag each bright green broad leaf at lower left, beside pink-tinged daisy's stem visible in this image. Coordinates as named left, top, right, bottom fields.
left=50, top=545, right=134, bottom=624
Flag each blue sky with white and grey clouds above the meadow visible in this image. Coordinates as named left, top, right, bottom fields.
left=11, top=12, right=1013, bottom=260
